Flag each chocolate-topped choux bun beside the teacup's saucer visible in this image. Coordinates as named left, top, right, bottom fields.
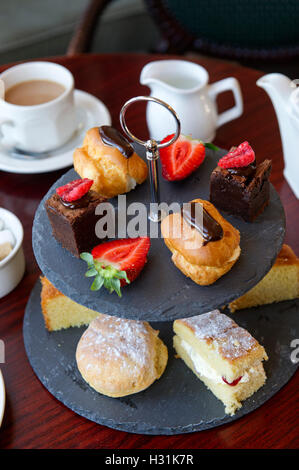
left=73, top=126, right=148, bottom=198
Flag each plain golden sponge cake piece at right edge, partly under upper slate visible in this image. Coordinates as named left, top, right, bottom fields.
left=229, top=245, right=299, bottom=312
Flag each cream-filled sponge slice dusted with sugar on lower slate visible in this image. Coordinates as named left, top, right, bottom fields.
left=173, top=310, right=268, bottom=415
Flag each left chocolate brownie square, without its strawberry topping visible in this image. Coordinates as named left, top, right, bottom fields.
left=45, top=190, right=106, bottom=257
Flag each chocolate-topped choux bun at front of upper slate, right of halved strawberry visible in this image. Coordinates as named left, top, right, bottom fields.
left=161, top=199, right=241, bottom=286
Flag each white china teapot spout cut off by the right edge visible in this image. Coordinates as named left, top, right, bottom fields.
left=256, top=73, right=299, bottom=198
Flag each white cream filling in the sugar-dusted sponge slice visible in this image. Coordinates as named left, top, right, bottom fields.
left=181, top=339, right=258, bottom=385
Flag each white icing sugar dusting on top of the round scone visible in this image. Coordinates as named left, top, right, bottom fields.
left=80, top=315, right=153, bottom=374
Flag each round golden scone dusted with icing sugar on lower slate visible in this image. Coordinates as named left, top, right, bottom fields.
left=76, top=314, right=168, bottom=397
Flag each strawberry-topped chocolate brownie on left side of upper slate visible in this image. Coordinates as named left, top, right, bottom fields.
left=45, top=178, right=106, bottom=257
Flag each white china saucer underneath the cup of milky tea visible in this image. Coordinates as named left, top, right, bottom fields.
left=0, top=90, right=111, bottom=174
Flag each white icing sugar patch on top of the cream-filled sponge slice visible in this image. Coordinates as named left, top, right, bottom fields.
left=181, top=310, right=237, bottom=339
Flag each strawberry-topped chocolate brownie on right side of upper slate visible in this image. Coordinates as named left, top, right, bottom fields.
left=210, top=142, right=272, bottom=222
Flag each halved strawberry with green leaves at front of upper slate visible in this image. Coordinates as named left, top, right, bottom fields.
left=80, top=237, right=151, bottom=297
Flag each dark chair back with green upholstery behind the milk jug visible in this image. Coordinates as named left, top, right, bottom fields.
left=144, top=0, right=299, bottom=60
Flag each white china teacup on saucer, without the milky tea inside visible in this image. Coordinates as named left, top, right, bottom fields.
left=0, top=62, right=76, bottom=152
